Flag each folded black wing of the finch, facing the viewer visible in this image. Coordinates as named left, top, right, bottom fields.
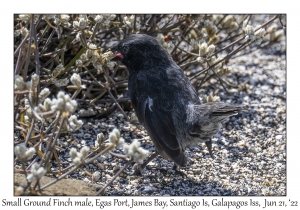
left=129, top=74, right=186, bottom=166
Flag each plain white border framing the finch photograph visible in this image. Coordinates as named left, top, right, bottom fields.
left=0, top=0, right=300, bottom=209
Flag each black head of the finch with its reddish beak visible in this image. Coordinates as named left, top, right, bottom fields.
left=111, top=34, right=172, bottom=71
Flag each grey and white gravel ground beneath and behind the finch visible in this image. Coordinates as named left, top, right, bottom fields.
left=14, top=14, right=286, bottom=196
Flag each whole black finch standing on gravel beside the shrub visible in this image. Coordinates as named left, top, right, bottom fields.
left=112, top=34, right=242, bottom=171
